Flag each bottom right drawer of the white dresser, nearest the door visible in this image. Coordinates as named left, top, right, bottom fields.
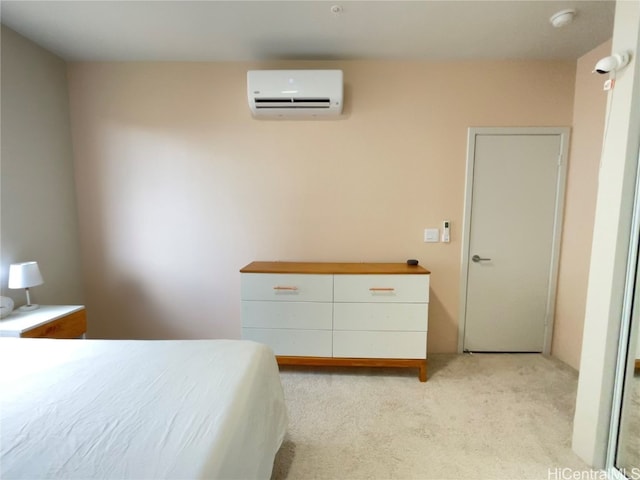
left=333, top=331, right=427, bottom=359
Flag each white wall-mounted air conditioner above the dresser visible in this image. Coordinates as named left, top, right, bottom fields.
left=247, top=70, right=342, bottom=118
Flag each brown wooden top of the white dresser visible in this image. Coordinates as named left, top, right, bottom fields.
left=240, top=262, right=431, bottom=275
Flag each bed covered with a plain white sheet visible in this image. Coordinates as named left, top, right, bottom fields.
left=0, top=338, right=287, bottom=480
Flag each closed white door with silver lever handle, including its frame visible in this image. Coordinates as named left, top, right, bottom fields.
left=461, top=128, right=568, bottom=353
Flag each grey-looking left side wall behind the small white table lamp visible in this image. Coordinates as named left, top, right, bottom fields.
left=0, top=25, right=84, bottom=306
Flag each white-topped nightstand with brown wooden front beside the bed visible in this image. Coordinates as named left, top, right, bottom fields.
left=0, top=305, right=87, bottom=338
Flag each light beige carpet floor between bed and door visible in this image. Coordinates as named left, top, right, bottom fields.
left=272, top=354, right=589, bottom=480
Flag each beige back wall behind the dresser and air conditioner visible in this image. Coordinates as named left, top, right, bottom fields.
left=69, top=61, right=575, bottom=352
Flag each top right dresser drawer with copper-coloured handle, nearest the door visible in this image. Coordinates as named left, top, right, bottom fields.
left=333, top=275, right=429, bottom=303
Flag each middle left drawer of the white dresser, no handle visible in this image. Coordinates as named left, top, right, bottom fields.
left=242, top=300, right=333, bottom=330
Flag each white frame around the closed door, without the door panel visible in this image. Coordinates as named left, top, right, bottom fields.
left=458, top=127, right=570, bottom=355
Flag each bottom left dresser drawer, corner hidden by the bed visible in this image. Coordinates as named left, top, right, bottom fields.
left=242, top=328, right=332, bottom=357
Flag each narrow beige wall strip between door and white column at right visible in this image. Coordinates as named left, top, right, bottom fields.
left=551, top=41, right=611, bottom=369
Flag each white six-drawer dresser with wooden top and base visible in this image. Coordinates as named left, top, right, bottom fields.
left=240, top=262, right=430, bottom=382
